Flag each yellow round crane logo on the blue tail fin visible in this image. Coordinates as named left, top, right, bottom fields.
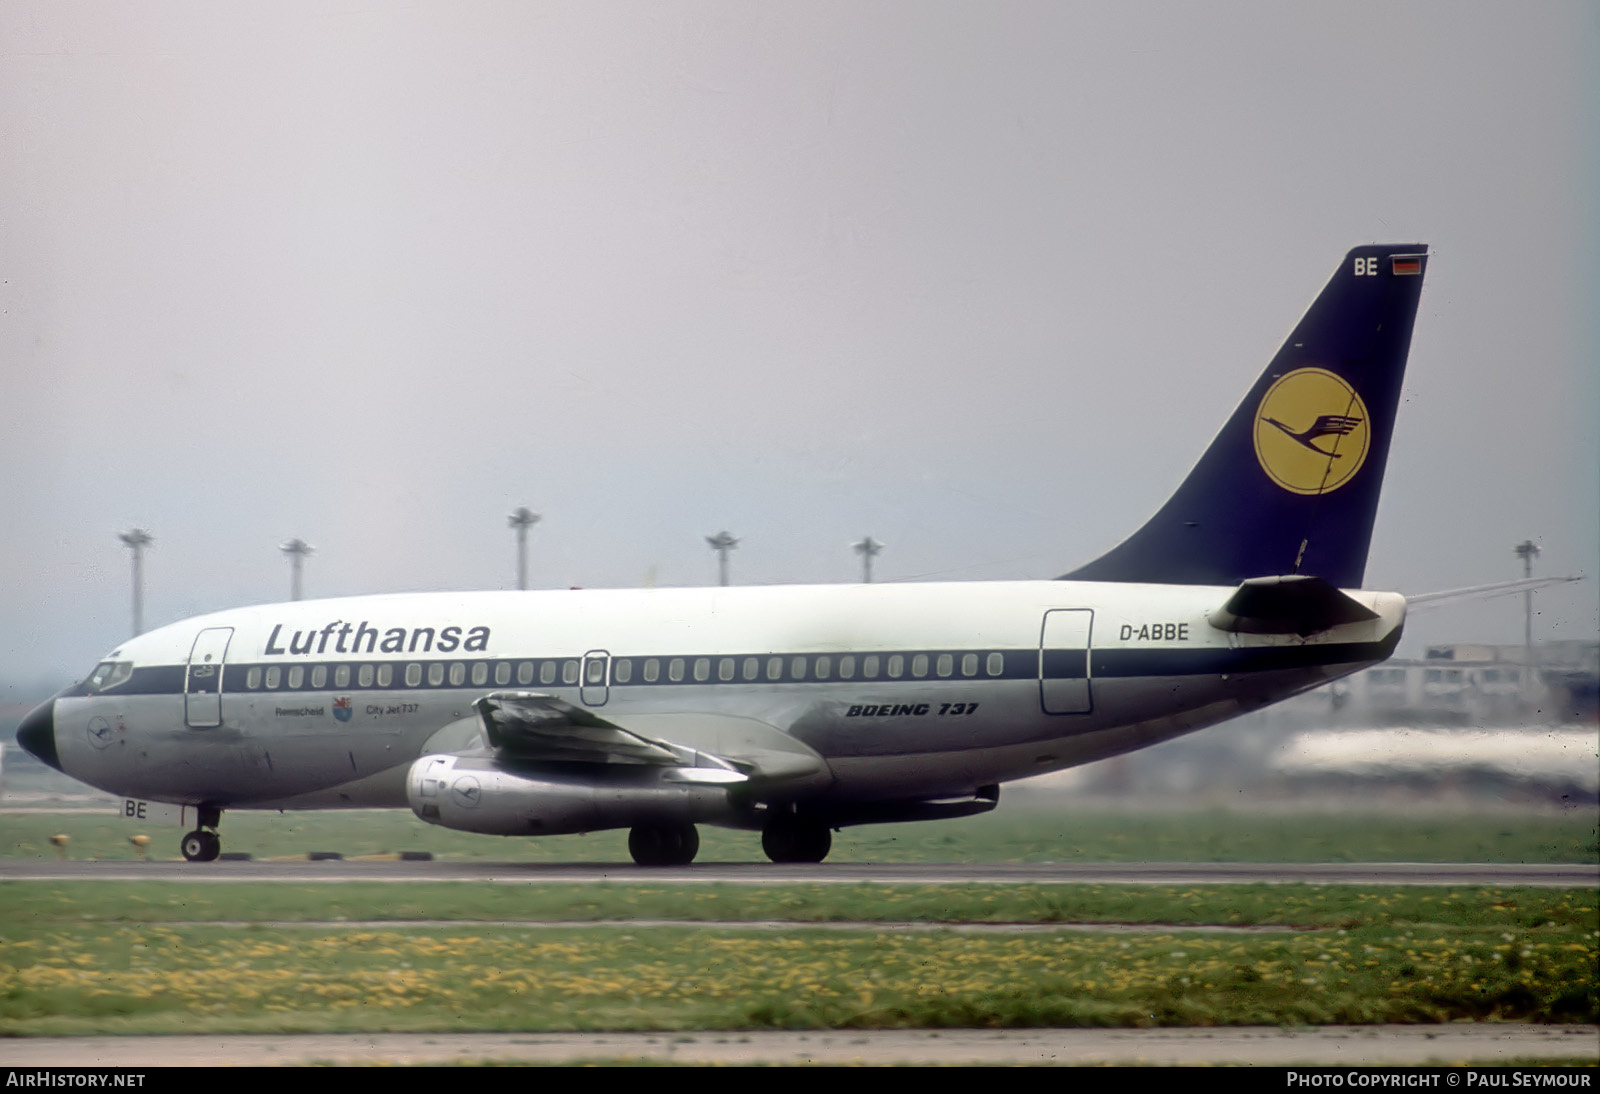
left=1256, top=368, right=1371, bottom=494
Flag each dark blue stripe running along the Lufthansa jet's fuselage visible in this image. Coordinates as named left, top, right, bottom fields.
left=64, top=633, right=1400, bottom=696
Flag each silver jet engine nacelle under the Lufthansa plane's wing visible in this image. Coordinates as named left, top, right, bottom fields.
left=406, top=753, right=734, bottom=835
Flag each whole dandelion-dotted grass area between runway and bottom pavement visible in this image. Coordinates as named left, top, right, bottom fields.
left=0, top=883, right=1600, bottom=1035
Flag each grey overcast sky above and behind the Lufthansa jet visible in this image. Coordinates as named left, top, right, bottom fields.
left=0, top=0, right=1600, bottom=683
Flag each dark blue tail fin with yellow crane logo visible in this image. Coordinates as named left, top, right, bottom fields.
left=1064, top=243, right=1427, bottom=589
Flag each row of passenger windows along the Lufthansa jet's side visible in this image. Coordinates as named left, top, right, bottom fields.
left=236, top=653, right=1005, bottom=691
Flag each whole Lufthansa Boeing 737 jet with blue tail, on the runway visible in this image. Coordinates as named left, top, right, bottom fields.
left=18, top=245, right=1427, bottom=865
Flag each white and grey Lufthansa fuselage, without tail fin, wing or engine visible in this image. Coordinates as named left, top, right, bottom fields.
left=43, top=581, right=1405, bottom=808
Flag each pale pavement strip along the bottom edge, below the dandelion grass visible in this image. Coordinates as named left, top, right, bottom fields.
left=0, top=1022, right=1600, bottom=1068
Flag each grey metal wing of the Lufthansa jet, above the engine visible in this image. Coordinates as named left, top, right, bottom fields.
left=472, top=691, right=829, bottom=784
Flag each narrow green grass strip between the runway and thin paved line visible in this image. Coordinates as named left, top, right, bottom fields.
left=0, top=881, right=1600, bottom=937
